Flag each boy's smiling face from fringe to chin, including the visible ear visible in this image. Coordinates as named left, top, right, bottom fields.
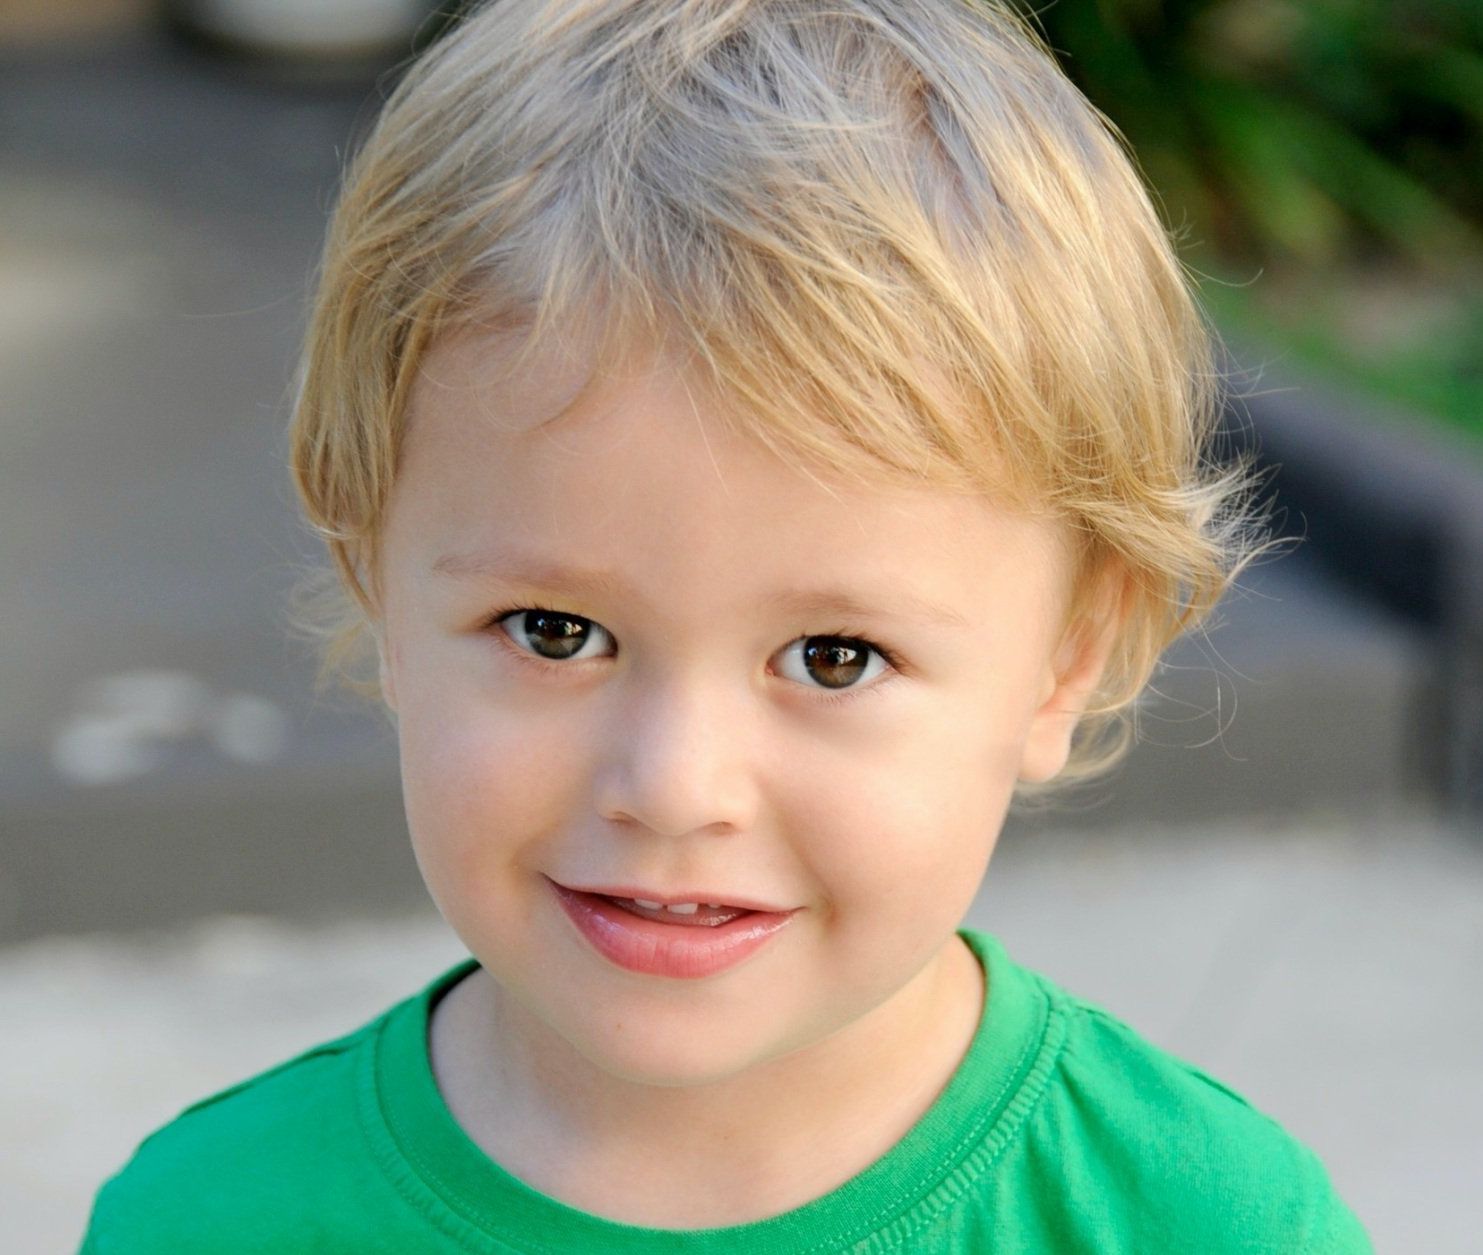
left=381, top=334, right=1100, bottom=1084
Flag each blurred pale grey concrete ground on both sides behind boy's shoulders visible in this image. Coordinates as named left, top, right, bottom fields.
left=14, top=817, right=1483, bottom=1255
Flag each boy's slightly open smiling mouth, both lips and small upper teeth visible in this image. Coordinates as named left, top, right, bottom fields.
left=547, top=880, right=795, bottom=979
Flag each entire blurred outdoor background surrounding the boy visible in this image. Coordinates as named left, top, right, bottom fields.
left=0, top=0, right=1483, bottom=1252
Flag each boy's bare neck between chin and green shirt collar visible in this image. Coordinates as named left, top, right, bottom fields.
left=432, top=936, right=985, bottom=1228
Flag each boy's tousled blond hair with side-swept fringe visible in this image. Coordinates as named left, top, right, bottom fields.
left=291, top=0, right=1265, bottom=798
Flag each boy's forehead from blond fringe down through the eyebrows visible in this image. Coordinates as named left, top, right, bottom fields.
left=387, top=331, right=1071, bottom=623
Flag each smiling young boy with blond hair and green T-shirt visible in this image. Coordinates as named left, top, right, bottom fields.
left=85, top=0, right=1369, bottom=1255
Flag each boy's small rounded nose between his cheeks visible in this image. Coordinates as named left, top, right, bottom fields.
left=595, top=678, right=758, bottom=837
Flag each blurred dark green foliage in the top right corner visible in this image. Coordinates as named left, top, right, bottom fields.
left=1035, top=0, right=1483, bottom=276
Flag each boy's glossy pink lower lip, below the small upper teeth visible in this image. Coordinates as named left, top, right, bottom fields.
left=552, top=881, right=793, bottom=981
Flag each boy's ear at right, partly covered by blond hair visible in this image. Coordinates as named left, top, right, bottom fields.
left=1019, top=573, right=1126, bottom=785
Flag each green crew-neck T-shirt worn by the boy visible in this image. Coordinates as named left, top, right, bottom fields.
left=83, top=932, right=1372, bottom=1255
